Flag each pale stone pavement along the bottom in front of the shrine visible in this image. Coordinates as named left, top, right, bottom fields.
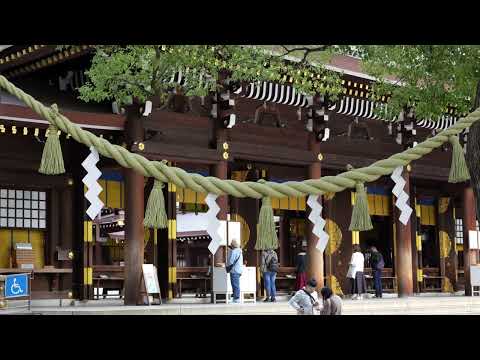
left=0, top=295, right=480, bottom=315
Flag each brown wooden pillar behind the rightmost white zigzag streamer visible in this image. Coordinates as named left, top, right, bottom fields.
left=393, top=170, right=414, bottom=297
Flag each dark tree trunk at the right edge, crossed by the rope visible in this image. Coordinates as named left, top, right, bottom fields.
left=465, top=81, right=480, bottom=224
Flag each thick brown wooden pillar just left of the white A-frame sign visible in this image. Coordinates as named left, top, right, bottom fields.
left=124, top=106, right=145, bottom=305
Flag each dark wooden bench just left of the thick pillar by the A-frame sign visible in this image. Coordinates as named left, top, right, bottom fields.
left=92, top=265, right=125, bottom=300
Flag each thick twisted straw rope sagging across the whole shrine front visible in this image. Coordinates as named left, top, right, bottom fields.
left=0, top=75, right=480, bottom=199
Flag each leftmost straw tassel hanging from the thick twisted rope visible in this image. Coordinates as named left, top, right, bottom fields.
left=38, top=104, right=65, bottom=175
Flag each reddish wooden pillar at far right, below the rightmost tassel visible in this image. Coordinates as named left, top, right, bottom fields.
left=463, top=186, right=477, bottom=296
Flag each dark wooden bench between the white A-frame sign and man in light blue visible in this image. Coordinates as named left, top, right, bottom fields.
left=175, top=267, right=211, bottom=298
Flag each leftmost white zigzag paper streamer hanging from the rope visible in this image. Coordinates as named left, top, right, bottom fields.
left=82, top=146, right=103, bottom=220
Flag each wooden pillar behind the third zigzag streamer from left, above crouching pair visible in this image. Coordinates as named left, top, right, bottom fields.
left=306, top=134, right=324, bottom=289
